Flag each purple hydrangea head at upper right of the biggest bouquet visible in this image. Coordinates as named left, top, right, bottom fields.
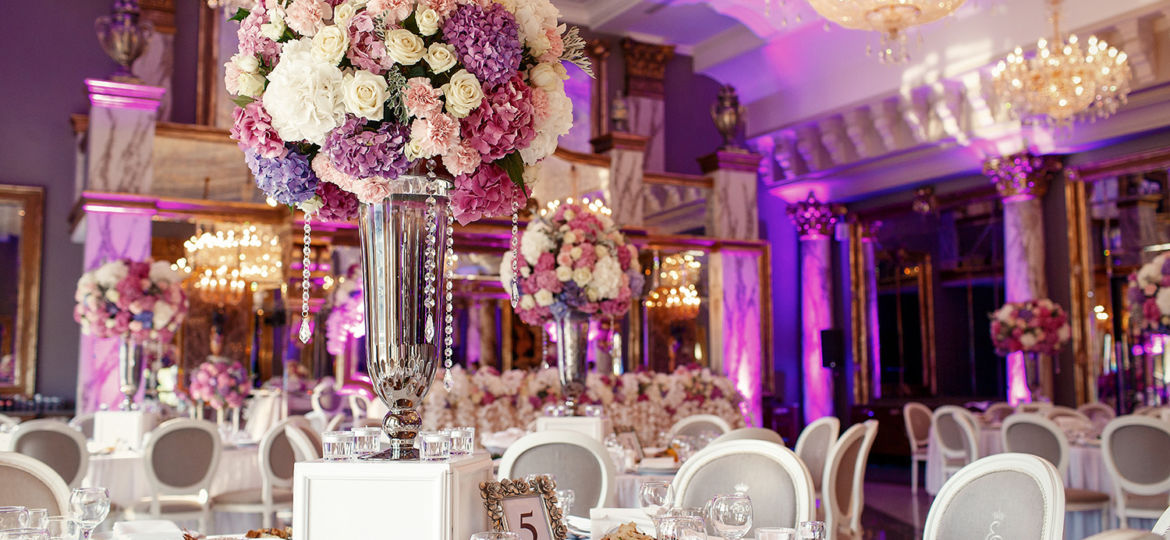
left=442, top=4, right=523, bottom=88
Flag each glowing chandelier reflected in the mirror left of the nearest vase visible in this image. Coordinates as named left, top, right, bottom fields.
left=173, top=223, right=284, bottom=304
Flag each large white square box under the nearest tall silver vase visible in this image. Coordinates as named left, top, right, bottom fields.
left=293, top=451, right=493, bottom=540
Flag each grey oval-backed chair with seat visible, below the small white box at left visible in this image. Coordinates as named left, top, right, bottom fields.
left=125, top=418, right=223, bottom=531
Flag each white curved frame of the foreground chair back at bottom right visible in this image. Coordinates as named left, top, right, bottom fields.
left=922, top=454, right=1065, bottom=540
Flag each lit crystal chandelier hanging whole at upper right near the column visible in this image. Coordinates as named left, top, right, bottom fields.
left=991, top=0, right=1133, bottom=126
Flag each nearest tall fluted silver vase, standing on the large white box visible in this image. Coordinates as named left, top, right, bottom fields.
left=359, top=175, right=449, bottom=461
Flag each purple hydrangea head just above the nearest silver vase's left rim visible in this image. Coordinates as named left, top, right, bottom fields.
left=321, top=116, right=411, bottom=179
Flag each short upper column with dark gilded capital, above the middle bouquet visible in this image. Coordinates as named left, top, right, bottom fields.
left=621, top=37, right=674, bottom=171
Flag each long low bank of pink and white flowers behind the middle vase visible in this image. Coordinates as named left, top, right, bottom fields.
left=422, top=366, right=744, bottom=445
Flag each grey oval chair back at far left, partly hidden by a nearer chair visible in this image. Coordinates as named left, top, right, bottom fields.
left=5, top=420, right=89, bottom=490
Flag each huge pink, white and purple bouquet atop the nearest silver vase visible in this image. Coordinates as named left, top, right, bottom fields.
left=225, top=0, right=592, bottom=223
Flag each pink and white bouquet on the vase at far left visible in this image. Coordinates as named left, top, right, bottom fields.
left=74, top=259, right=188, bottom=342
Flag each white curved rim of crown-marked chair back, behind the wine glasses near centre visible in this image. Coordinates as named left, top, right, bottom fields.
left=672, top=439, right=819, bottom=527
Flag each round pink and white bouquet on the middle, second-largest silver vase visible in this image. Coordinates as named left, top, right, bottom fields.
left=500, top=199, right=645, bottom=326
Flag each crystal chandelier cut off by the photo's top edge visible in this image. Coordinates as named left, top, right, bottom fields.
left=808, top=0, right=965, bottom=62
